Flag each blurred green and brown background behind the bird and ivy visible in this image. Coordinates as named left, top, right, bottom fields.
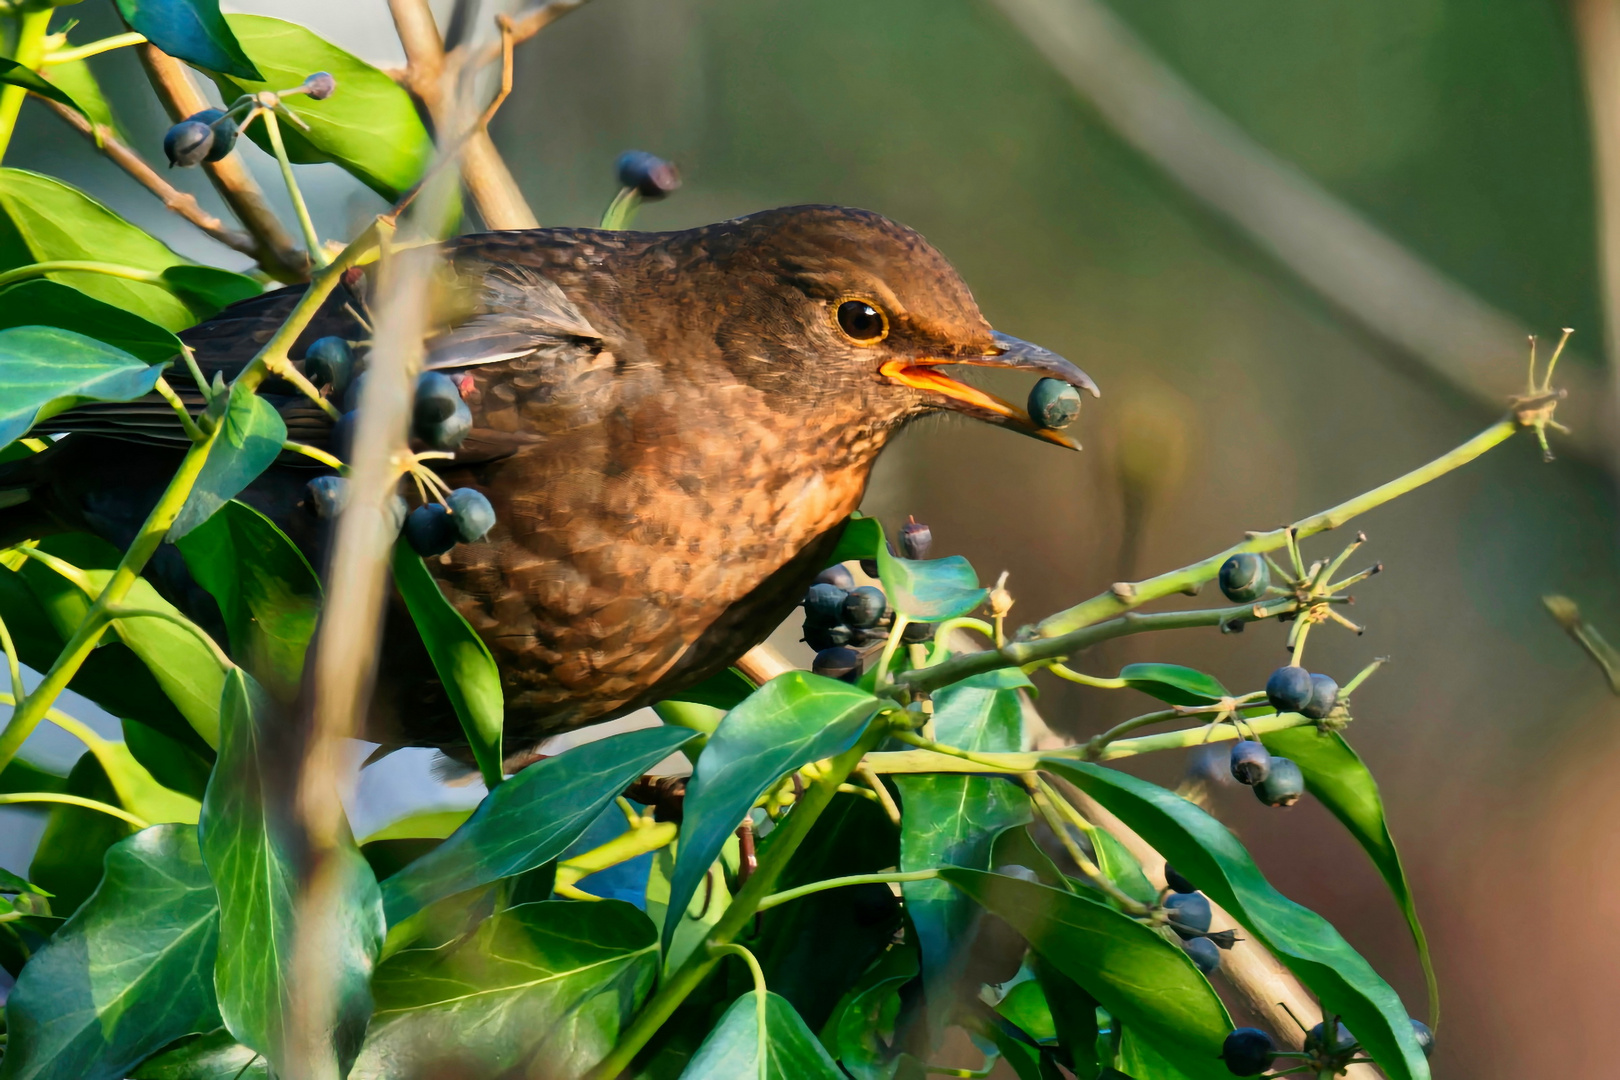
left=0, top=0, right=1620, bottom=1080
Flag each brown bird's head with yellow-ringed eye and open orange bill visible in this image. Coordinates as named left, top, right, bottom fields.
left=697, top=206, right=1097, bottom=449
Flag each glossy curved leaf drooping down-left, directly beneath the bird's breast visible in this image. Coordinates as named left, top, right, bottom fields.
left=664, top=672, right=881, bottom=949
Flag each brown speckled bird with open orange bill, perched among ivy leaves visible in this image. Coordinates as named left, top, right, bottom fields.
left=0, top=206, right=1097, bottom=758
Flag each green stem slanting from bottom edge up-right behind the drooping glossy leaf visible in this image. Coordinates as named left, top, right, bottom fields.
left=585, top=717, right=889, bottom=1080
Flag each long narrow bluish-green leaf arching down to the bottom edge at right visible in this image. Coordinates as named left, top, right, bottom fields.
left=1042, top=758, right=1429, bottom=1080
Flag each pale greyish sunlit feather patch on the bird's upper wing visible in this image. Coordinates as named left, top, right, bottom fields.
left=424, top=262, right=603, bottom=369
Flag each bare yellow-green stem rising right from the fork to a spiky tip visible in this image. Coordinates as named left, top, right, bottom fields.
left=1035, top=416, right=1523, bottom=638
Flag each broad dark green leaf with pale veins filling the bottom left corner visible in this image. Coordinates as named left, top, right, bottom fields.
left=3, top=824, right=219, bottom=1080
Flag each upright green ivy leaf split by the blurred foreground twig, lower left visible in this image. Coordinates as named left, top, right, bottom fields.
left=199, top=667, right=382, bottom=1069
